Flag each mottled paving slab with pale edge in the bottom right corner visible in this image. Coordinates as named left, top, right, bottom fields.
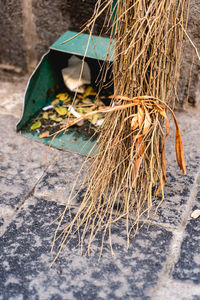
left=149, top=172, right=200, bottom=300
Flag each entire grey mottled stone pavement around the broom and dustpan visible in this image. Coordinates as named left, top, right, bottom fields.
left=0, top=79, right=200, bottom=300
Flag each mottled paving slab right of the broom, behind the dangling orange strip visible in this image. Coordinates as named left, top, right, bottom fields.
left=153, top=109, right=200, bottom=228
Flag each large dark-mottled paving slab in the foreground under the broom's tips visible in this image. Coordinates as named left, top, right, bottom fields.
left=0, top=197, right=172, bottom=300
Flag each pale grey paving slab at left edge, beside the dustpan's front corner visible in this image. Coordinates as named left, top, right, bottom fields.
left=0, top=115, right=57, bottom=232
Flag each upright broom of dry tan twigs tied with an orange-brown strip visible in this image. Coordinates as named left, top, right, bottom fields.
left=50, top=0, right=189, bottom=262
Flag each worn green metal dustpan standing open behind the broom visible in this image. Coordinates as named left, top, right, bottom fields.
left=17, top=31, right=114, bottom=154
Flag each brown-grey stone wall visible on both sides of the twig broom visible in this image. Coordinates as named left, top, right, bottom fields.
left=0, top=0, right=200, bottom=104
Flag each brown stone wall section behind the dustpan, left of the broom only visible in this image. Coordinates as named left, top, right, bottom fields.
left=0, top=0, right=103, bottom=72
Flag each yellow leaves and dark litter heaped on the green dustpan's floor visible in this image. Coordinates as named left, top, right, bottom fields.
left=24, top=85, right=110, bottom=139
